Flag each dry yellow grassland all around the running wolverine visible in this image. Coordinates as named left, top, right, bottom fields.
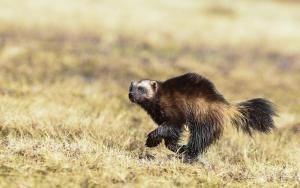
left=0, top=0, right=300, bottom=187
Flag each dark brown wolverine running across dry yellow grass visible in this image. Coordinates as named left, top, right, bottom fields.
left=129, top=73, right=276, bottom=162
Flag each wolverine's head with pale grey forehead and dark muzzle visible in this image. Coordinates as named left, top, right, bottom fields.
left=128, top=80, right=158, bottom=103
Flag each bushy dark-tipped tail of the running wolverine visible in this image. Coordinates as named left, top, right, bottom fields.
left=231, top=98, right=276, bottom=135
